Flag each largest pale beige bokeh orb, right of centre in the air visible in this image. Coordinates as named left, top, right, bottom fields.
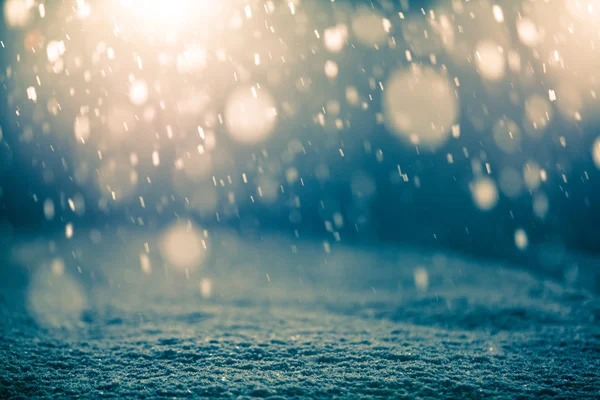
left=383, top=67, right=459, bottom=147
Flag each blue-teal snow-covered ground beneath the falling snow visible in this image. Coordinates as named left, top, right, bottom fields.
left=0, top=232, right=600, bottom=399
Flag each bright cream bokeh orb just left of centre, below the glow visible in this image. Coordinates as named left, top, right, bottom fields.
left=225, top=87, right=277, bottom=144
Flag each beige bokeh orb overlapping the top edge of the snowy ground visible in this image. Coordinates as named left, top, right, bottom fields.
left=160, top=222, right=208, bottom=270
